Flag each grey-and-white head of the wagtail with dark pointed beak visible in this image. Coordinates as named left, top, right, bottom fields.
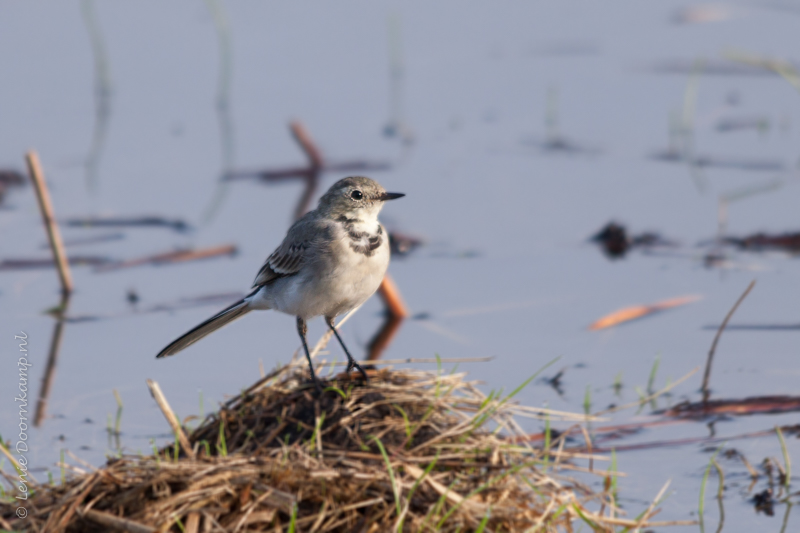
left=319, top=176, right=405, bottom=220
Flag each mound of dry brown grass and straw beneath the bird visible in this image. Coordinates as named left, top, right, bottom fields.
left=0, top=363, right=680, bottom=533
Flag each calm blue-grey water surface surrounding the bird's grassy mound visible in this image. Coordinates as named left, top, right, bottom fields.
left=0, top=2, right=800, bottom=531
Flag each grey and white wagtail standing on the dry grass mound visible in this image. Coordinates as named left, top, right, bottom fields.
left=156, top=177, right=405, bottom=389
